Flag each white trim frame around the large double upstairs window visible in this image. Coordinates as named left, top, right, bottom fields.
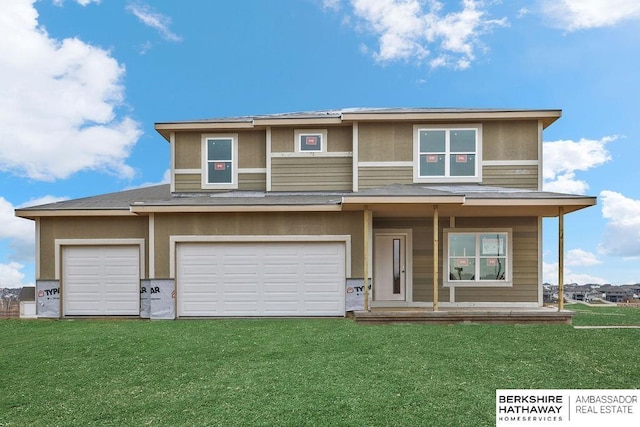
left=413, top=123, right=482, bottom=183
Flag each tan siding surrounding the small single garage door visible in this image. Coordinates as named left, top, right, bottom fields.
left=39, top=216, right=149, bottom=279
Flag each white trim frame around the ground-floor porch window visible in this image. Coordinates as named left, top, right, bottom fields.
left=442, top=228, right=513, bottom=288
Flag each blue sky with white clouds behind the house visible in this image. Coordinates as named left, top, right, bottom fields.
left=0, top=0, right=640, bottom=287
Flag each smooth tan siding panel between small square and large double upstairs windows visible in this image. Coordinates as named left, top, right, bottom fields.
left=358, top=123, right=413, bottom=162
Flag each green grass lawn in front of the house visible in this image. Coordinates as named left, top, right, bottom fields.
left=0, top=320, right=640, bottom=426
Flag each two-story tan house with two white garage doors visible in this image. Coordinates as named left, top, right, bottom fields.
left=17, top=108, right=596, bottom=318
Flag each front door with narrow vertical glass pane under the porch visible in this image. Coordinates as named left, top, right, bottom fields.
left=373, top=233, right=407, bottom=301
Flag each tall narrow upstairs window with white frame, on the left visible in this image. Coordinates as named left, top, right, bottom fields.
left=202, top=134, right=238, bottom=189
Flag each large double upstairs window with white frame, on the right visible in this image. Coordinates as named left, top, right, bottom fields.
left=414, top=125, right=482, bottom=182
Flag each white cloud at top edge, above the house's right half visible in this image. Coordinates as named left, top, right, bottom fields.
left=332, top=0, right=508, bottom=69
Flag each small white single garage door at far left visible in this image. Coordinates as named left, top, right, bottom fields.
left=62, top=245, right=140, bottom=316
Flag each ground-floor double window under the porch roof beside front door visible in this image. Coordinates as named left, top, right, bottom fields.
left=445, top=229, right=512, bottom=286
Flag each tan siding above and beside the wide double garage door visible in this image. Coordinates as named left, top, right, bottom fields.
left=155, top=212, right=363, bottom=277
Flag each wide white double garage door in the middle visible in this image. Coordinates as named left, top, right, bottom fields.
left=176, top=242, right=345, bottom=317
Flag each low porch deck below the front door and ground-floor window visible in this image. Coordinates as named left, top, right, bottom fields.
left=353, top=307, right=575, bottom=325
